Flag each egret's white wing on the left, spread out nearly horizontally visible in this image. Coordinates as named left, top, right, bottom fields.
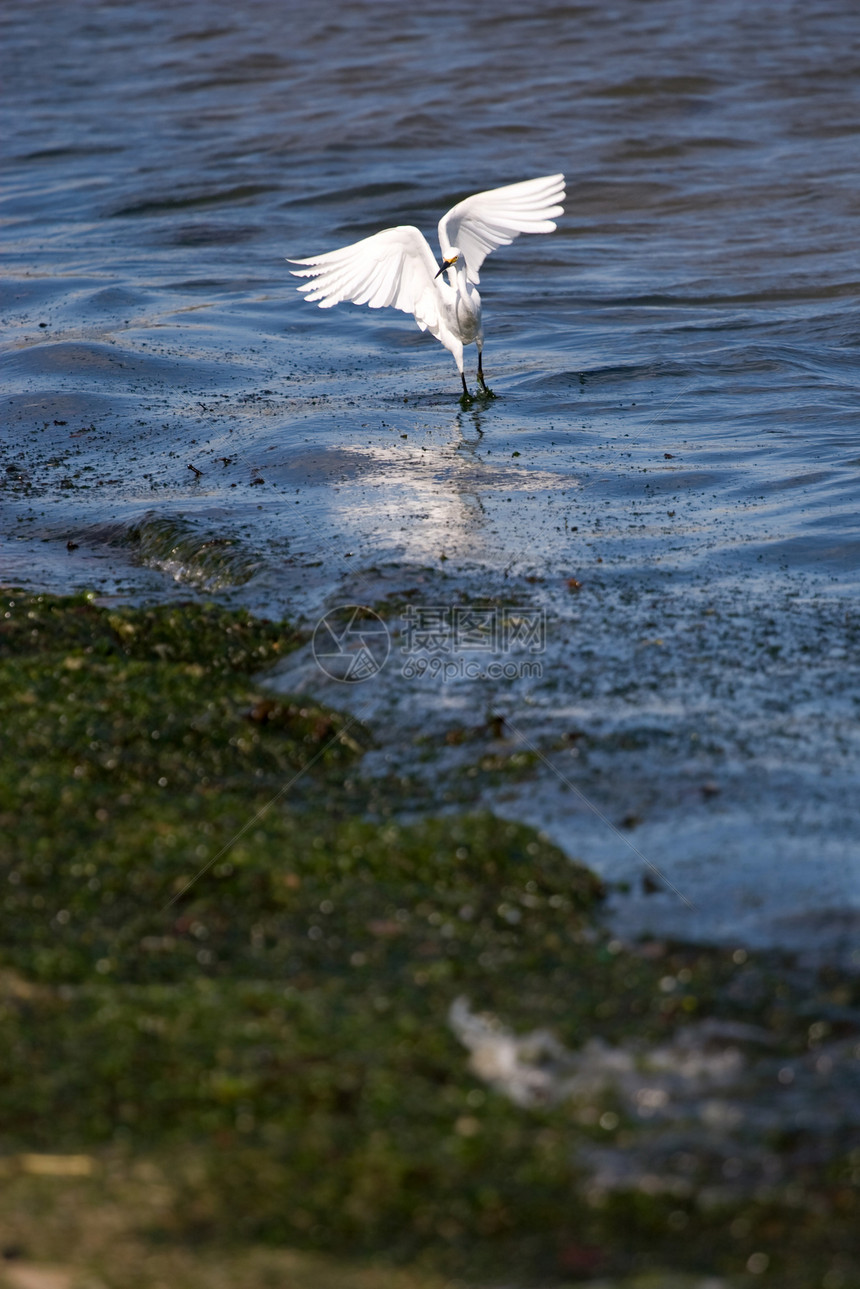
left=290, top=224, right=440, bottom=331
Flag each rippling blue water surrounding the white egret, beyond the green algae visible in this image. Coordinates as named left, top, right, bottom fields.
left=0, top=0, right=860, bottom=960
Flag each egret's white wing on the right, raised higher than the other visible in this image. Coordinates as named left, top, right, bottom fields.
left=438, top=174, right=565, bottom=282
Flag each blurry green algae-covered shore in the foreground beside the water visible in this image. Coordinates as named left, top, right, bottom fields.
left=0, top=590, right=860, bottom=1289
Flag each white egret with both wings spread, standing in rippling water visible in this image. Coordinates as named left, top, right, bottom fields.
left=289, top=174, right=565, bottom=398
